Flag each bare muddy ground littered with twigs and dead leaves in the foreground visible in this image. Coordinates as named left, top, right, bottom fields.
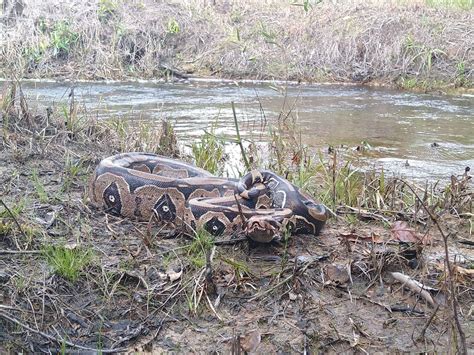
left=0, top=105, right=474, bottom=353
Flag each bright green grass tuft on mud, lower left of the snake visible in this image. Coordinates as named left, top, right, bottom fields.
left=43, top=246, right=93, bottom=282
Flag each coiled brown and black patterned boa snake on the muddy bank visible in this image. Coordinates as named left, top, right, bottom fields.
left=89, top=153, right=327, bottom=242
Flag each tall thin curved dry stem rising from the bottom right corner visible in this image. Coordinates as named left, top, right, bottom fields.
left=398, top=179, right=467, bottom=354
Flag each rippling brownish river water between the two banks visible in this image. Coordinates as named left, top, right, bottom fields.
left=12, top=81, right=474, bottom=179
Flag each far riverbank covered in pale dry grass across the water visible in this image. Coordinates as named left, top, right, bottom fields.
left=0, top=0, right=474, bottom=91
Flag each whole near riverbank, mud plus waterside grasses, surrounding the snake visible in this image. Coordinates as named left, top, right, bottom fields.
left=0, top=81, right=474, bottom=353
